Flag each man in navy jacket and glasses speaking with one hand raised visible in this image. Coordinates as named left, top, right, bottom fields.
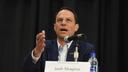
left=24, top=7, right=93, bottom=72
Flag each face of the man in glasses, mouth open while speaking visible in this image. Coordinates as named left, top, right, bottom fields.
left=54, top=10, right=79, bottom=38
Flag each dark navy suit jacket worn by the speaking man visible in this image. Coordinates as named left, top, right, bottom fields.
left=23, top=40, right=93, bottom=72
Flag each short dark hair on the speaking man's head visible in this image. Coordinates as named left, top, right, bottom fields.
left=55, top=7, right=78, bottom=23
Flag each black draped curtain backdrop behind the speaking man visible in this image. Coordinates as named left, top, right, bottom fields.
left=0, top=0, right=128, bottom=72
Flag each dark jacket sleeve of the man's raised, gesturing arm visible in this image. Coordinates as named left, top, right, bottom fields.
left=23, top=47, right=46, bottom=72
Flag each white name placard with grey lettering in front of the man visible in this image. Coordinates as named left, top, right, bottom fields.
left=45, top=61, right=90, bottom=72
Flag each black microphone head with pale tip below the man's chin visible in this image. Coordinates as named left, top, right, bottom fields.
left=64, top=34, right=85, bottom=42
